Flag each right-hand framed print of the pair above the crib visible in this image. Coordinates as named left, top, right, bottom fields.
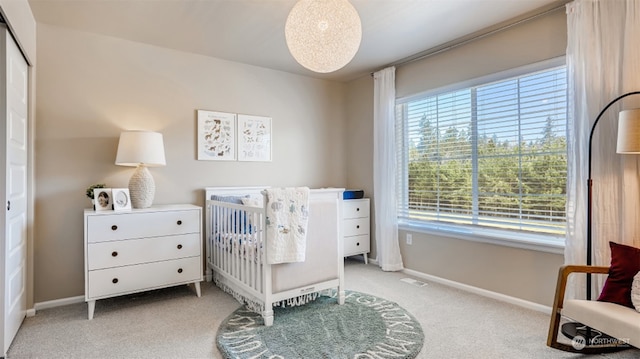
left=237, top=114, right=271, bottom=162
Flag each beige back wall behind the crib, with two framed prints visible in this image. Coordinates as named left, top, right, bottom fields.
left=34, top=24, right=346, bottom=302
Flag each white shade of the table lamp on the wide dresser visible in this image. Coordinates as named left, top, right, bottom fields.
left=116, top=131, right=167, bottom=167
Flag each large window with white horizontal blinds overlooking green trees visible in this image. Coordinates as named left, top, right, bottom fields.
left=396, top=65, right=567, bottom=243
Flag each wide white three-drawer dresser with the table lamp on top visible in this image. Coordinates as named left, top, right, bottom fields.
left=84, top=204, right=203, bottom=319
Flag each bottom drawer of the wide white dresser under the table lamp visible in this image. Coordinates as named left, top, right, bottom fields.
left=86, top=257, right=202, bottom=300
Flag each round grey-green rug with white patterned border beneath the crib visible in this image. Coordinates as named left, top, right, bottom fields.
left=216, top=291, right=424, bottom=359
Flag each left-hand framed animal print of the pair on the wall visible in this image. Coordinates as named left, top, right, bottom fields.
left=197, top=110, right=236, bottom=161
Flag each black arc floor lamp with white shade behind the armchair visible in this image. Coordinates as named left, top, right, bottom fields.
left=562, top=91, right=640, bottom=349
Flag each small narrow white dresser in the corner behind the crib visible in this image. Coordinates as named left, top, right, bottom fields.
left=342, top=198, right=371, bottom=264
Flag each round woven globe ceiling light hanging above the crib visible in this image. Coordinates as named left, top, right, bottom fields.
left=285, top=0, right=362, bottom=73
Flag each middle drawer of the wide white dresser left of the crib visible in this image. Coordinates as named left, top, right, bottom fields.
left=87, top=233, right=201, bottom=270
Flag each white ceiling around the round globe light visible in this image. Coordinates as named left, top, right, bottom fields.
left=28, top=0, right=567, bottom=81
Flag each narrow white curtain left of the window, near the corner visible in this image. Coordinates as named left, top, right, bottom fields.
left=373, top=67, right=403, bottom=271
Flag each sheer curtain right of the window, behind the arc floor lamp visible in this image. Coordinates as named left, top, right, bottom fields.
left=565, top=0, right=640, bottom=298
